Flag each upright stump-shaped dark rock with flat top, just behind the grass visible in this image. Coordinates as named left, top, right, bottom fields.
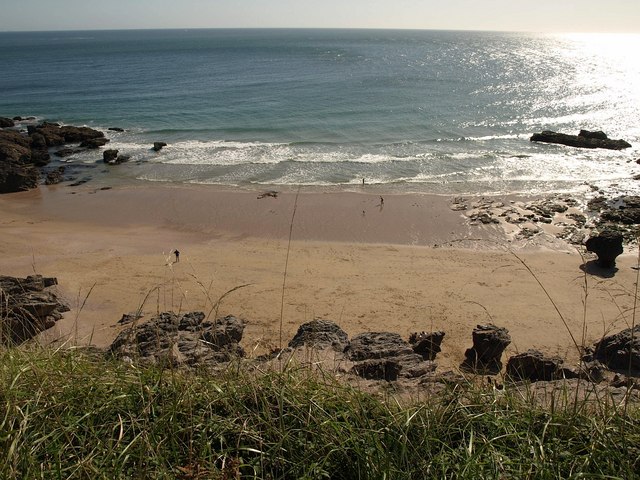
left=462, top=324, right=511, bottom=373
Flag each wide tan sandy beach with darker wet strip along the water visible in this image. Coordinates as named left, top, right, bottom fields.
left=0, top=182, right=637, bottom=369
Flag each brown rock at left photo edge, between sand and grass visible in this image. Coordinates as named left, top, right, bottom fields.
left=0, top=275, right=69, bottom=345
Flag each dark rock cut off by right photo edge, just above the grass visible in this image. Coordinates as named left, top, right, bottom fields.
left=594, top=325, right=640, bottom=375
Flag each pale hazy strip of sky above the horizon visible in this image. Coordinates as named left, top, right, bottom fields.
left=0, top=0, right=640, bottom=33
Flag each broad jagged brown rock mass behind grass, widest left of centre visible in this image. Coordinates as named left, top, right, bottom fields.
left=109, top=312, right=244, bottom=366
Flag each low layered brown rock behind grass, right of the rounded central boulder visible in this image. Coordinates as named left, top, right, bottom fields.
left=345, top=332, right=436, bottom=381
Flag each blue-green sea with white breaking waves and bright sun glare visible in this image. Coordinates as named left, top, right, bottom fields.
left=0, top=29, right=640, bottom=194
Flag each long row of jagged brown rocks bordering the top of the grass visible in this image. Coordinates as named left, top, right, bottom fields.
left=105, top=312, right=640, bottom=400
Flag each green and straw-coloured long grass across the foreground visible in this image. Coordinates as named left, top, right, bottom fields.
left=0, top=349, right=640, bottom=479
